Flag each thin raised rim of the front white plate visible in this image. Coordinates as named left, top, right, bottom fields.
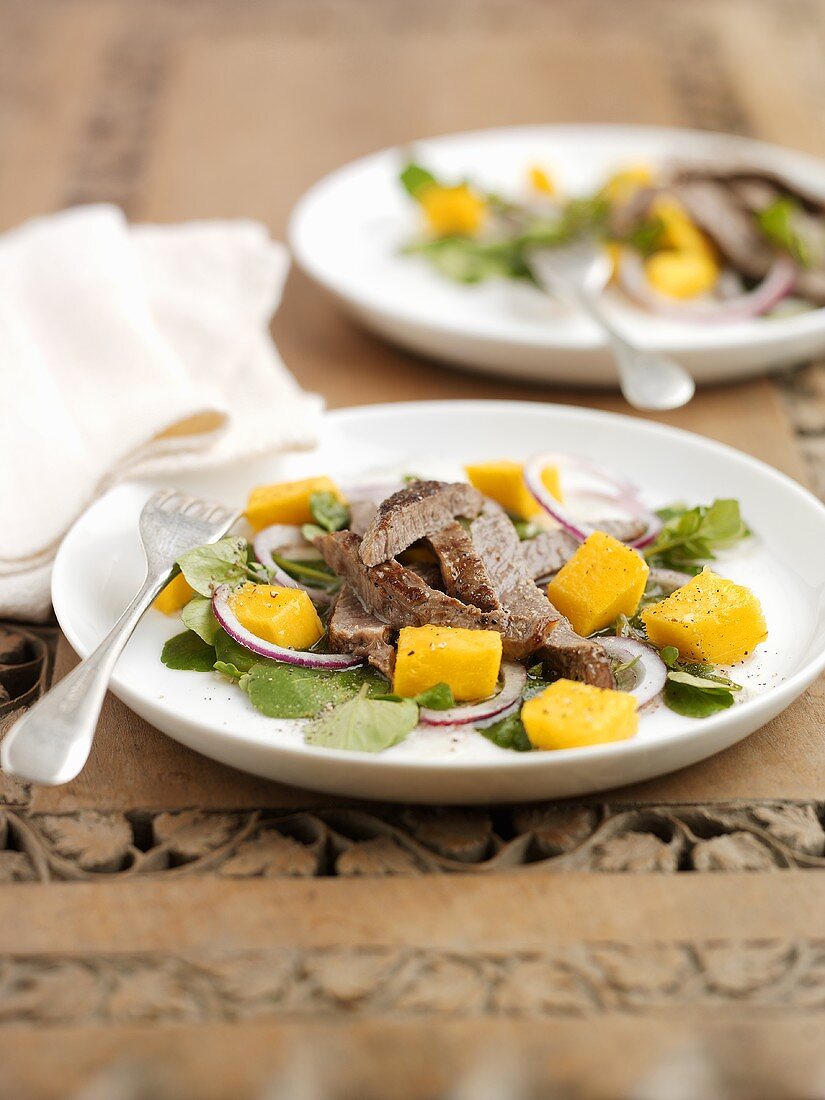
left=52, top=398, right=825, bottom=790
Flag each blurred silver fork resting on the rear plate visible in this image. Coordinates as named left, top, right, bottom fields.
left=528, top=239, right=696, bottom=409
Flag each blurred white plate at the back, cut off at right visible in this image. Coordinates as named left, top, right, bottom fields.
left=289, top=125, right=825, bottom=385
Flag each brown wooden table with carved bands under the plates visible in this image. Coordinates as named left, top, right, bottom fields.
left=0, top=0, right=825, bottom=1100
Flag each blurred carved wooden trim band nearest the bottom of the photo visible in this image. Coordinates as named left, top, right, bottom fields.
left=0, top=939, right=825, bottom=1026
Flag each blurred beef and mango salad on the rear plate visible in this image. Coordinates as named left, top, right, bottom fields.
left=400, top=162, right=825, bottom=325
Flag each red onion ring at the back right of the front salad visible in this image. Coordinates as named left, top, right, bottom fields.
left=524, top=451, right=662, bottom=550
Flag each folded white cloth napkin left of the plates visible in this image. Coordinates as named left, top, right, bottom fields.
left=0, top=205, right=321, bottom=620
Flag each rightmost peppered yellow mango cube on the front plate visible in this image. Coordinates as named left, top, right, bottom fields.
left=641, top=569, right=768, bottom=664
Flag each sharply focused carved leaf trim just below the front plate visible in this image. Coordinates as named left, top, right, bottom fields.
left=0, top=802, right=825, bottom=882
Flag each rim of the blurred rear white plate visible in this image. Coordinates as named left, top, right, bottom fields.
left=286, top=122, right=825, bottom=354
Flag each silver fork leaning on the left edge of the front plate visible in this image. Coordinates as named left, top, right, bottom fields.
left=0, top=490, right=239, bottom=785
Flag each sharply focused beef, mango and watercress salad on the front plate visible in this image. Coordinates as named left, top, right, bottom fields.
left=156, top=453, right=768, bottom=752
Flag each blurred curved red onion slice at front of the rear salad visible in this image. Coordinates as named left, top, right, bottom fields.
left=618, top=251, right=798, bottom=325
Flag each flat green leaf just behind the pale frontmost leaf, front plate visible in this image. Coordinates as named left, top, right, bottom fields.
left=242, top=661, right=397, bottom=718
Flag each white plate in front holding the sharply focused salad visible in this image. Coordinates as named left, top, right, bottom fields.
left=53, top=402, right=825, bottom=802
